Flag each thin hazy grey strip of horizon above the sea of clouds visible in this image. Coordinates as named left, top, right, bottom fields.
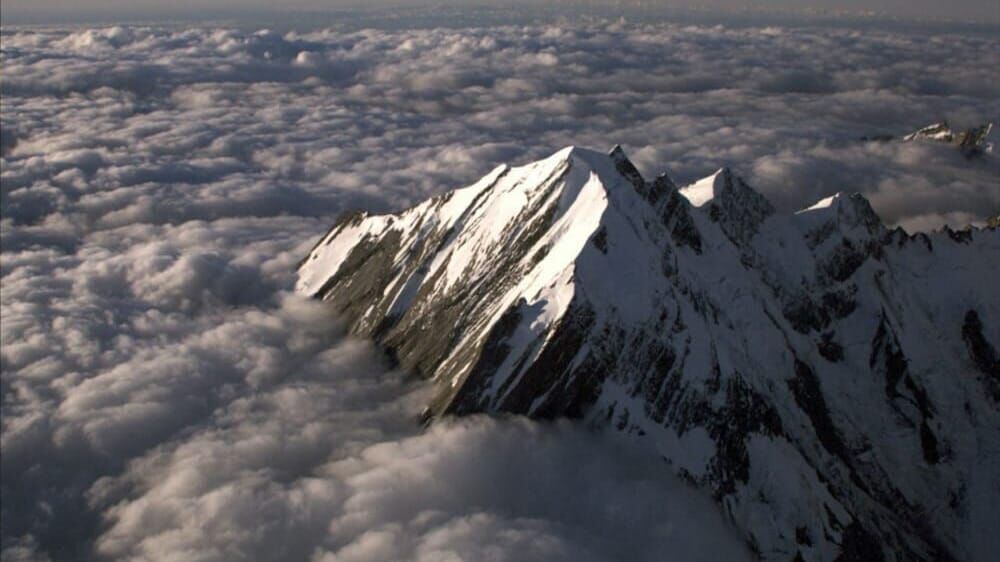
left=2, top=0, right=1000, bottom=25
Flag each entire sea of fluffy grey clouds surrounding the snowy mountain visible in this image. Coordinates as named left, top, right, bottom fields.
left=0, top=15, right=1000, bottom=560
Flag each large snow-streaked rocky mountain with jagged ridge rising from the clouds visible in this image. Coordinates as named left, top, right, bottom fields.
left=297, top=147, right=1000, bottom=561
